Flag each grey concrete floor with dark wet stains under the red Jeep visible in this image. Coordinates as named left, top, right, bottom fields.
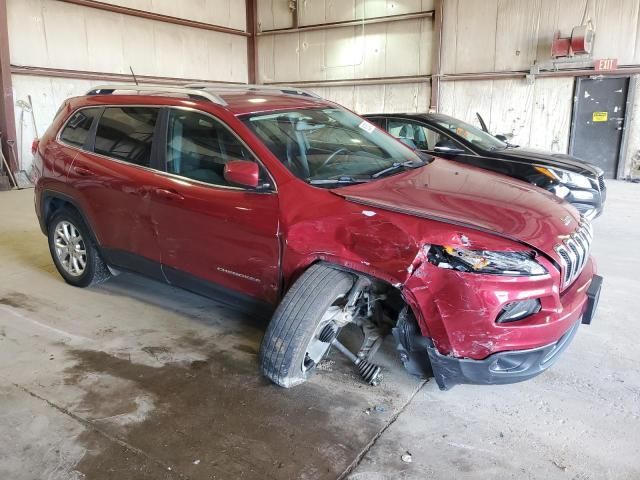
left=0, top=182, right=640, bottom=480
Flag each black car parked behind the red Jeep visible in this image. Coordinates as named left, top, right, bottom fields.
left=364, top=113, right=606, bottom=220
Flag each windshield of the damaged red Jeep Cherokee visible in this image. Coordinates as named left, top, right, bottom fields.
left=243, top=108, right=425, bottom=187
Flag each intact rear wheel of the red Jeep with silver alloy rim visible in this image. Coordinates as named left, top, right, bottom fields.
left=48, top=208, right=111, bottom=287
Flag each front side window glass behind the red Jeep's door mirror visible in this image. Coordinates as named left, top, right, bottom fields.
left=167, top=109, right=254, bottom=186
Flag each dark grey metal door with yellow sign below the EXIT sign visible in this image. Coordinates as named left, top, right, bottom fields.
left=569, top=77, right=629, bottom=178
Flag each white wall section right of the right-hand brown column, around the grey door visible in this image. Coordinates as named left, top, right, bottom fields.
left=440, top=0, right=640, bottom=175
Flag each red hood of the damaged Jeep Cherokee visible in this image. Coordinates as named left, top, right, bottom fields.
left=333, top=158, right=580, bottom=257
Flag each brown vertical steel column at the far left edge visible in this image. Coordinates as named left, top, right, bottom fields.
left=0, top=0, right=18, bottom=171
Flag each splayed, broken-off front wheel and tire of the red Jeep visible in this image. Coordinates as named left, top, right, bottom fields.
left=260, top=264, right=355, bottom=388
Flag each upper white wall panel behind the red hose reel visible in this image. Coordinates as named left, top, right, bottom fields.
left=443, top=0, right=640, bottom=73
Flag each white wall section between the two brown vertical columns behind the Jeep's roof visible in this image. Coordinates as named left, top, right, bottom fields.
left=258, top=0, right=433, bottom=113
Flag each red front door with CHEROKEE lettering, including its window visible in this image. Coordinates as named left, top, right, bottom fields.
left=152, top=108, right=280, bottom=303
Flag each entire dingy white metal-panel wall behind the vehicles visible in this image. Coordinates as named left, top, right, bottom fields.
left=8, top=0, right=640, bottom=174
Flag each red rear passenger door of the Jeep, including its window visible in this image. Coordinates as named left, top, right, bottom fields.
left=69, top=106, right=162, bottom=278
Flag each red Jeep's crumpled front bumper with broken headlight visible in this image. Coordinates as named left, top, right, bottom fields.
left=393, top=245, right=601, bottom=390
